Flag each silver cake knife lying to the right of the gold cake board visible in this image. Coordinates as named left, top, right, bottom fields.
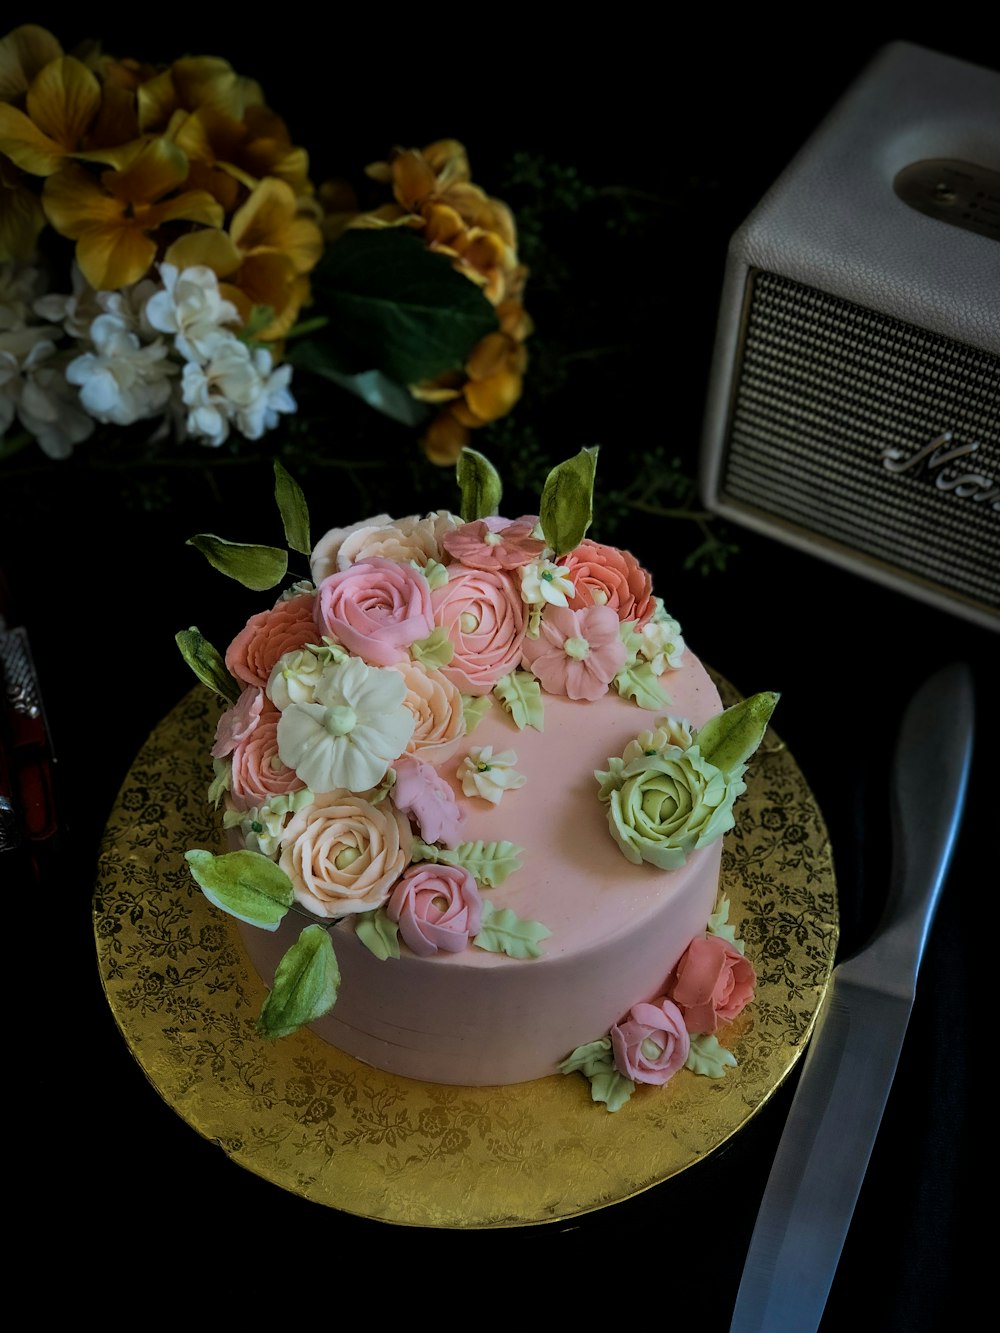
left=731, top=663, right=973, bottom=1333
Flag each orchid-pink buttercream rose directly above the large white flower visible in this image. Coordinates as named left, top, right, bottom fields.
left=316, top=559, right=435, bottom=667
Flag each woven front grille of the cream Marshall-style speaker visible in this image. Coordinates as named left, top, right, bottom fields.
left=720, top=271, right=1000, bottom=613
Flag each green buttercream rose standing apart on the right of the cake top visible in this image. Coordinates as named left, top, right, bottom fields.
left=599, top=745, right=747, bottom=870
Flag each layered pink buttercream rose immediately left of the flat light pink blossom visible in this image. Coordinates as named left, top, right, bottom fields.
left=431, top=565, right=527, bottom=694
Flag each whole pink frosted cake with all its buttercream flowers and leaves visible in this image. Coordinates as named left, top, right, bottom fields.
left=179, top=451, right=775, bottom=1110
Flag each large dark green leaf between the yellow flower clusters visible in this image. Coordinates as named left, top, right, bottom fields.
left=300, top=227, right=499, bottom=384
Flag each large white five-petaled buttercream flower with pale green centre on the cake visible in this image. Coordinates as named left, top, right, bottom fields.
left=277, top=657, right=413, bottom=792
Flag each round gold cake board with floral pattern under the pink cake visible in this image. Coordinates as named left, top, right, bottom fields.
left=93, top=673, right=839, bottom=1228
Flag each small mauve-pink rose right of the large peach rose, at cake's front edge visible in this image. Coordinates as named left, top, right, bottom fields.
left=385, top=864, right=483, bottom=958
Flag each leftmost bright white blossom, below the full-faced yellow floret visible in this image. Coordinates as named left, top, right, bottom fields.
left=65, top=315, right=176, bottom=425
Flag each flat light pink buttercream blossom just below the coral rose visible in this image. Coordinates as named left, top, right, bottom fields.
left=524, top=607, right=627, bottom=700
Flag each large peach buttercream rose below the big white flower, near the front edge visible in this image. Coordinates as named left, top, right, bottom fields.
left=279, top=790, right=412, bottom=917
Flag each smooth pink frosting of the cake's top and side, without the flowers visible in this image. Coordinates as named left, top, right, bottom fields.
left=241, top=651, right=721, bottom=1085
